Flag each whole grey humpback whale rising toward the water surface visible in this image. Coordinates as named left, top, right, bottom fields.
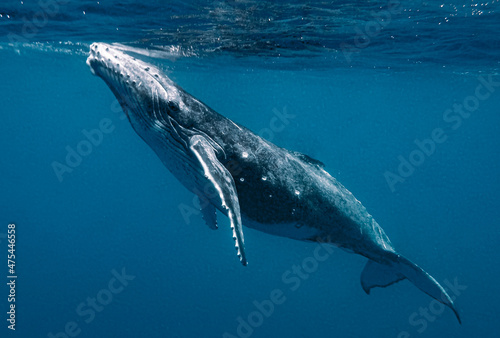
left=87, top=43, right=460, bottom=322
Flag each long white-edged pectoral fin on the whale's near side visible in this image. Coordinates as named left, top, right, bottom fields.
left=189, top=135, right=247, bottom=265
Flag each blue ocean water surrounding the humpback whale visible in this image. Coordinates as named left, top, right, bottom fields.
left=0, top=0, right=500, bottom=338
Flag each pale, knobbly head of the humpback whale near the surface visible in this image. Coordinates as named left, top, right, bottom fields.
left=87, top=43, right=186, bottom=128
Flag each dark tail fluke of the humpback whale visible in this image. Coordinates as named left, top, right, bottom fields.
left=361, top=253, right=462, bottom=324
